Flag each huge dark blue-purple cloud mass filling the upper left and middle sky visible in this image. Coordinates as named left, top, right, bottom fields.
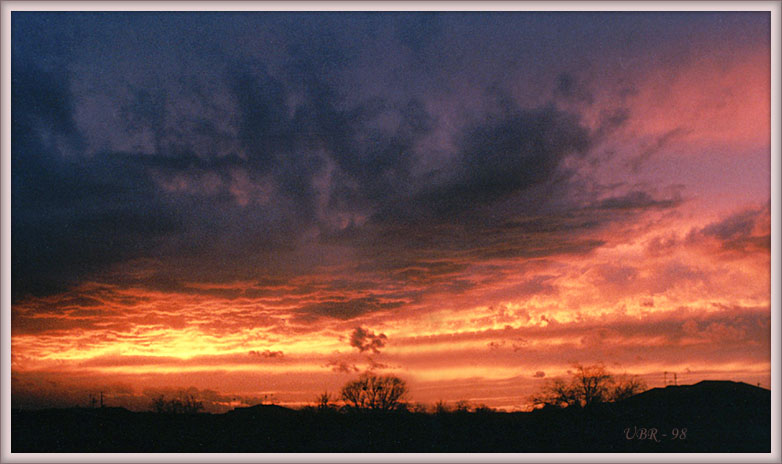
left=12, top=13, right=692, bottom=308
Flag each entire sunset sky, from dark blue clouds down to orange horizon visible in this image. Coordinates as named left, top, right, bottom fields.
left=11, top=12, right=771, bottom=412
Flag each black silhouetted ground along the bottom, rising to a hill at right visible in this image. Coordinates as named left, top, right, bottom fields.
left=11, top=381, right=771, bottom=453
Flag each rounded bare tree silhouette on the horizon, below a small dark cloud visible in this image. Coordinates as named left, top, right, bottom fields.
left=342, top=372, right=407, bottom=411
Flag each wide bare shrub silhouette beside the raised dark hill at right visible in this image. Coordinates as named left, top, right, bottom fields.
left=531, top=364, right=646, bottom=408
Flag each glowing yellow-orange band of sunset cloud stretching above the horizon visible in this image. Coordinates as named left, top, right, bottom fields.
left=12, top=203, right=770, bottom=408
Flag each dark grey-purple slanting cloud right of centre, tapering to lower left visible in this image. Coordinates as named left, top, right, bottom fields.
left=396, top=106, right=591, bottom=221
